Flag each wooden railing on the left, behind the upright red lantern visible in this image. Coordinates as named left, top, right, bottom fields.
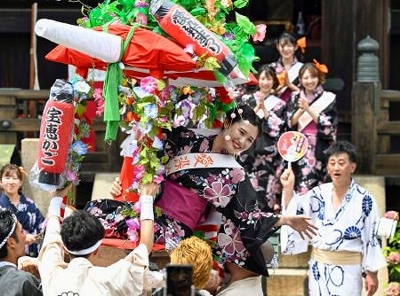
left=0, top=89, right=122, bottom=174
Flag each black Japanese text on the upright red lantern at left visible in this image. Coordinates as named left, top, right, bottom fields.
left=40, top=107, right=63, bottom=166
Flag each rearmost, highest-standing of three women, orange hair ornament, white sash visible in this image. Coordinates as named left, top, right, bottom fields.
left=270, top=32, right=305, bottom=102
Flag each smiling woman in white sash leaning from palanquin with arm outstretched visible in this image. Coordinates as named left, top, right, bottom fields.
left=111, top=105, right=314, bottom=275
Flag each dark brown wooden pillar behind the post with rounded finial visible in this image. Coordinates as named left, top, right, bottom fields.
left=321, top=0, right=390, bottom=115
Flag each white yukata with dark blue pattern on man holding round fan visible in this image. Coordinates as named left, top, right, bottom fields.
left=281, top=180, right=386, bottom=296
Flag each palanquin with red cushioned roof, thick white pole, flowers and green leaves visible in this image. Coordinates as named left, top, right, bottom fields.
left=35, top=0, right=265, bottom=252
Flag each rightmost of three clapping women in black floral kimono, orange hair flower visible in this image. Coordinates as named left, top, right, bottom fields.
left=287, top=60, right=338, bottom=194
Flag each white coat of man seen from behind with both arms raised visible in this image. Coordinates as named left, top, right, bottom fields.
left=38, top=217, right=149, bottom=296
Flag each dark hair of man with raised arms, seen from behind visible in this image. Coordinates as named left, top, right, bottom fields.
left=61, top=210, right=105, bottom=257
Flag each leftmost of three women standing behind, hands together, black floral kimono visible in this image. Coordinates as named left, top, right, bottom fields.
left=239, top=65, right=286, bottom=212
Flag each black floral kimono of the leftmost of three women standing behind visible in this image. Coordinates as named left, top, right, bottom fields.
left=239, top=92, right=287, bottom=212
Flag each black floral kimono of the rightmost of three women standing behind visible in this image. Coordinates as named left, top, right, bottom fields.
left=287, top=86, right=338, bottom=194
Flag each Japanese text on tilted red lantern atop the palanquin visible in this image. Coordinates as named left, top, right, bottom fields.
left=172, top=9, right=222, bottom=55
